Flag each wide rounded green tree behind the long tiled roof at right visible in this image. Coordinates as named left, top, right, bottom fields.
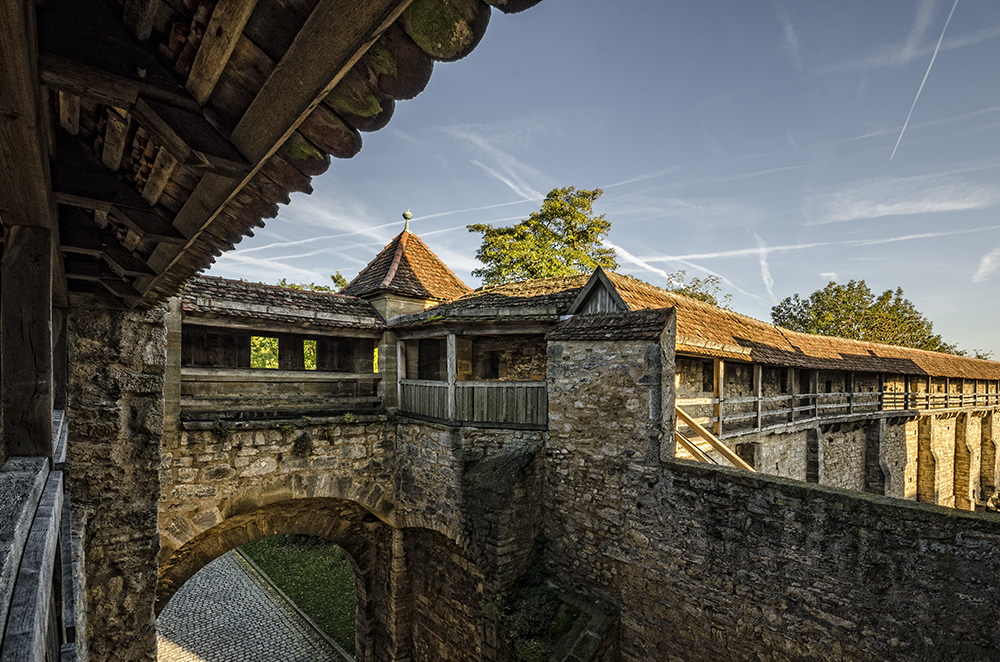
left=771, top=280, right=962, bottom=354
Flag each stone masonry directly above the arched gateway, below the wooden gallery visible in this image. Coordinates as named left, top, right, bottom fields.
left=160, top=417, right=396, bottom=562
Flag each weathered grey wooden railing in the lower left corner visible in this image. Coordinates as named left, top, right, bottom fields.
left=0, top=412, right=77, bottom=662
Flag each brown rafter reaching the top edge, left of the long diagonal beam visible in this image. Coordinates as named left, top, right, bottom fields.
left=185, top=0, right=257, bottom=106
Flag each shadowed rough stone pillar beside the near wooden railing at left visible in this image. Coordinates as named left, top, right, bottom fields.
left=68, top=299, right=166, bottom=662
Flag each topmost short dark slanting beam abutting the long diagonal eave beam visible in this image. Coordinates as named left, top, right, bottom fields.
left=135, top=98, right=250, bottom=176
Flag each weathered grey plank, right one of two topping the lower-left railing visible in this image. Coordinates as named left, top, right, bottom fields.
left=0, top=471, right=63, bottom=662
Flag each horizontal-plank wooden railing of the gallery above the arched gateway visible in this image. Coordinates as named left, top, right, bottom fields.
left=181, top=367, right=381, bottom=418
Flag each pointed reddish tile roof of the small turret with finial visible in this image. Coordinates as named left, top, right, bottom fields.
left=340, top=230, right=472, bottom=301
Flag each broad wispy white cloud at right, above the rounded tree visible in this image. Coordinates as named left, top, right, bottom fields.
left=806, top=175, right=1000, bottom=225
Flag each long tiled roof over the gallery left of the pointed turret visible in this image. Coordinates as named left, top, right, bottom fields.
left=181, top=276, right=384, bottom=329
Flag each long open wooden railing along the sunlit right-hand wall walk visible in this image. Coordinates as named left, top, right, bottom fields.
left=677, top=391, right=1000, bottom=437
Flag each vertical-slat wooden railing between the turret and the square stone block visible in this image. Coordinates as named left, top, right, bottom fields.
left=399, top=379, right=548, bottom=428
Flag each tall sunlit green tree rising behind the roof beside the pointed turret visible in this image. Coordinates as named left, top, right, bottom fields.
left=467, top=186, right=618, bottom=285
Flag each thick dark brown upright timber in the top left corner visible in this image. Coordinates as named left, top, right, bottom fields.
left=0, top=2, right=53, bottom=228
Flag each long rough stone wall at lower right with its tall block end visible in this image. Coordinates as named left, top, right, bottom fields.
left=545, top=334, right=1000, bottom=662
